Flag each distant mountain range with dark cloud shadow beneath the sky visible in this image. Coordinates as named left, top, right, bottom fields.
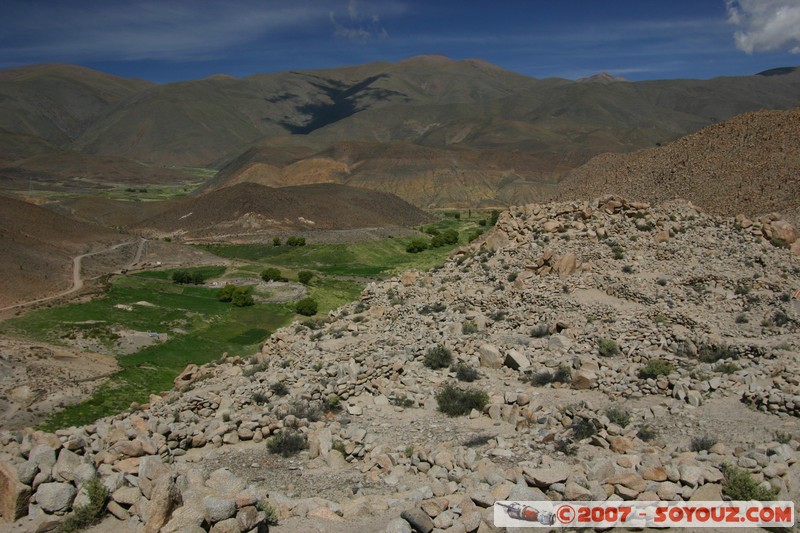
left=0, top=56, right=800, bottom=208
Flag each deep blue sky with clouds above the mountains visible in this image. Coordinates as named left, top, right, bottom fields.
left=0, top=0, right=800, bottom=82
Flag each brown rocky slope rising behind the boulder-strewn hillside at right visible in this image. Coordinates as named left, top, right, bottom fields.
left=557, top=109, right=800, bottom=220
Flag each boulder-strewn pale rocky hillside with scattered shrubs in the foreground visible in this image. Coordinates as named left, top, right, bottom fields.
left=0, top=197, right=800, bottom=533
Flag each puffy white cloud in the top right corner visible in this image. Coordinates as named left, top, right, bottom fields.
left=726, top=0, right=800, bottom=54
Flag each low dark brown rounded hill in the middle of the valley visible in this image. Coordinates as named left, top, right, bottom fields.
left=137, top=183, right=430, bottom=240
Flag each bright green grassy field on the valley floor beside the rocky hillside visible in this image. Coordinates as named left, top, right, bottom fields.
left=2, top=276, right=294, bottom=430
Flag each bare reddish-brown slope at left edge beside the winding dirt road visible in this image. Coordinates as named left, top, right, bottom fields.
left=0, top=195, right=122, bottom=307
